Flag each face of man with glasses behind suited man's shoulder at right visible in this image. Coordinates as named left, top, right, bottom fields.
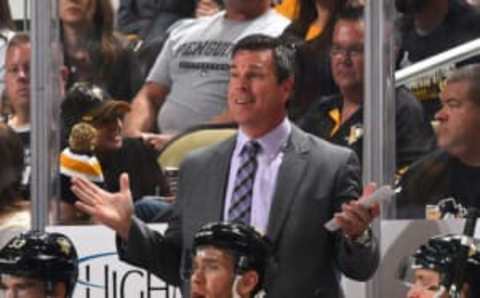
left=330, top=20, right=364, bottom=93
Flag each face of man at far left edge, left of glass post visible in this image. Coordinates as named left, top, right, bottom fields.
left=5, top=43, right=31, bottom=111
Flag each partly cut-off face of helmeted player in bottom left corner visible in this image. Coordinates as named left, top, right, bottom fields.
left=0, top=275, right=46, bottom=298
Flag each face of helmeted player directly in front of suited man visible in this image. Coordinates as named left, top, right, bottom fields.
left=190, top=246, right=235, bottom=298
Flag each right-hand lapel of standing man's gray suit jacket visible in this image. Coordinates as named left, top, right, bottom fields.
left=267, top=126, right=308, bottom=243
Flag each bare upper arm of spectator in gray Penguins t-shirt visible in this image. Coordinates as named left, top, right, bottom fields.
left=124, top=82, right=170, bottom=137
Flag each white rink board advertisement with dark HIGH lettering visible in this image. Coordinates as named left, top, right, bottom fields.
left=47, top=225, right=181, bottom=298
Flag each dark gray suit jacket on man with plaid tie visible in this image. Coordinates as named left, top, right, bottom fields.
left=122, top=127, right=379, bottom=298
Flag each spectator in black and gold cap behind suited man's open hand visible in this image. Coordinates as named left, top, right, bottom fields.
left=61, top=83, right=169, bottom=221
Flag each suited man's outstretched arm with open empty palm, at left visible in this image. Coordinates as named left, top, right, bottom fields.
left=72, top=173, right=181, bottom=285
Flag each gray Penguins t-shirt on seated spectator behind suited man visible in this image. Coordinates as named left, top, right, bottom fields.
left=147, top=10, right=289, bottom=133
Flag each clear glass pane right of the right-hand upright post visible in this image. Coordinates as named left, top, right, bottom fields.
left=395, top=1, right=480, bottom=219
